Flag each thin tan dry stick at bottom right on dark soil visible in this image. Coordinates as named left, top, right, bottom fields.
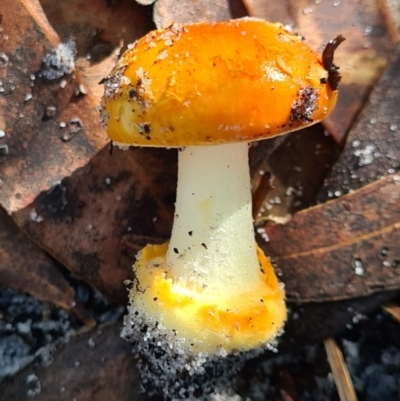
left=324, top=338, right=357, bottom=401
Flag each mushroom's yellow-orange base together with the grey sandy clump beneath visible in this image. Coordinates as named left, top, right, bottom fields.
left=122, top=243, right=286, bottom=400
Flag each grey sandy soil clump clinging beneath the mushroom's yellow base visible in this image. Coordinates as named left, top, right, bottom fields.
left=122, top=311, right=270, bottom=401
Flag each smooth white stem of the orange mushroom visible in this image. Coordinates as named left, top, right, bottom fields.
left=167, top=142, right=260, bottom=295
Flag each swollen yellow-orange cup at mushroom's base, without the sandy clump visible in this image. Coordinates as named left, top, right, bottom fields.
left=126, top=243, right=286, bottom=355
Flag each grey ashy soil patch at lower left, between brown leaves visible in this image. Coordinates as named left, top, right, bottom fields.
left=0, top=282, right=123, bottom=383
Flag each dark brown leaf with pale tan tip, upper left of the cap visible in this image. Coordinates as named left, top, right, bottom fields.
left=41, top=0, right=154, bottom=104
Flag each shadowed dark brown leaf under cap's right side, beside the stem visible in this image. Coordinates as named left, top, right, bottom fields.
left=250, top=124, right=339, bottom=220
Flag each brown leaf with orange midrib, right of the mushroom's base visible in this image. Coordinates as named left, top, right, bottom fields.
left=263, top=175, right=400, bottom=302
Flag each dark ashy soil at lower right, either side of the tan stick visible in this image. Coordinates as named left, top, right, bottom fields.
left=228, top=312, right=400, bottom=401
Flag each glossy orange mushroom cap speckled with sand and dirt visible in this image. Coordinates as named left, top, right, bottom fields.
left=102, top=18, right=337, bottom=147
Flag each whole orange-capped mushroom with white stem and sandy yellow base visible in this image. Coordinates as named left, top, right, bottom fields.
left=101, top=18, right=340, bottom=394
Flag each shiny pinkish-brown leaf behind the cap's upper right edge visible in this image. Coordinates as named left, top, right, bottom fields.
left=245, top=0, right=394, bottom=144
